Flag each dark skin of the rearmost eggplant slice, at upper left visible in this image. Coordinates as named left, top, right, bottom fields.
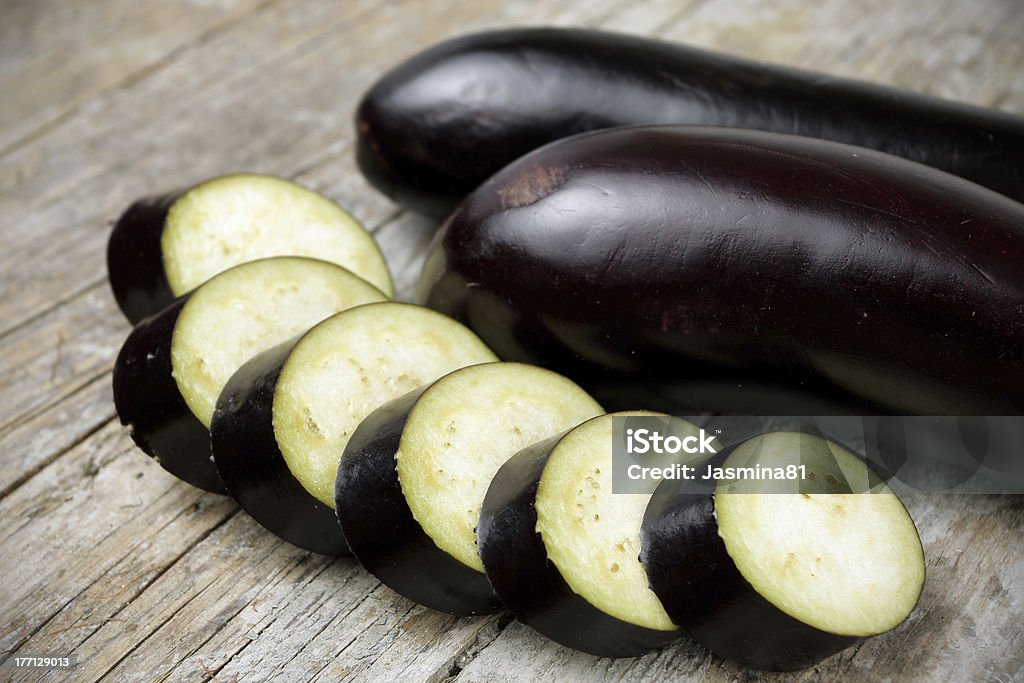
left=106, top=191, right=183, bottom=325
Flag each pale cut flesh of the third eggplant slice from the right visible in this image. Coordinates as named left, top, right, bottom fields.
left=396, top=362, right=603, bottom=572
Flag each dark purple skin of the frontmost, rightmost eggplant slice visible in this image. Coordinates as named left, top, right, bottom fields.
left=640, top=483, right=860, bottom=671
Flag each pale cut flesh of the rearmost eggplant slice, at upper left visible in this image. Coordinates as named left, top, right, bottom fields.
left=161, top=173, right=394, bottom=297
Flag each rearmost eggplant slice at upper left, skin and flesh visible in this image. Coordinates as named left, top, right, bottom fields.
left=106, top=173, right=394, bottom=325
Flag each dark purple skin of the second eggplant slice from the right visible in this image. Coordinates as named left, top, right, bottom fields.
left=476, top=434, right=682, bottom=657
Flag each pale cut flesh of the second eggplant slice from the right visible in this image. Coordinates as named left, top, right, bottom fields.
left=537, top=412, right=699, bottom=631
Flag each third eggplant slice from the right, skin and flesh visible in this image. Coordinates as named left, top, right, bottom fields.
left=335, top=362, right=602, bottom=615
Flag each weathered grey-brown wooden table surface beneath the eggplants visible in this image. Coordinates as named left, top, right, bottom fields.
left=0, top=0, right=1024, bottom=681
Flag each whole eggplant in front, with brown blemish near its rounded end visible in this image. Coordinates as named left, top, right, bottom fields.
left=419, top=126, right=1024, bottom=415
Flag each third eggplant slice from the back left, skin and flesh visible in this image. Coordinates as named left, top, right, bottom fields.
left=210, top=302, right=497, bottom=555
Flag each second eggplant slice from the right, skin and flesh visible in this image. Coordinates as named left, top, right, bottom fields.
left=477, top=412, right=699, bottom=657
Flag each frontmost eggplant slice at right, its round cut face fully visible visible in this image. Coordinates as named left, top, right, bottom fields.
left=640, top=432, right=925, bottom=671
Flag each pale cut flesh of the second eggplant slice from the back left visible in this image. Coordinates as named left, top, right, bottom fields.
left=171, top=256, right=387, bottom=429
